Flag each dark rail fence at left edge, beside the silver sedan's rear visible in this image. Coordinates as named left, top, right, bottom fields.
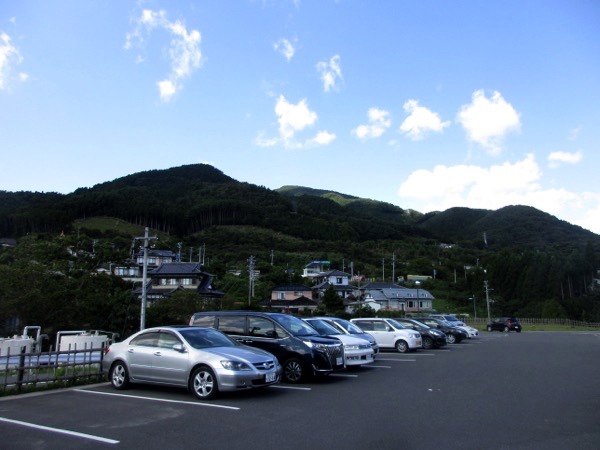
left=0, top=345, right=104, bottom=395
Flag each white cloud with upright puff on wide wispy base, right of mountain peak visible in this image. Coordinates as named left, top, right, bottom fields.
left=254, top=95, right=336, bottom=148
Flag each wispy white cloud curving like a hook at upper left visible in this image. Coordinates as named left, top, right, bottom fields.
left=124, top=9, right=202, bottom=101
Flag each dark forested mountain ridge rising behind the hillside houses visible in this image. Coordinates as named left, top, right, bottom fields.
left=0, top=164, right=600, bottom=330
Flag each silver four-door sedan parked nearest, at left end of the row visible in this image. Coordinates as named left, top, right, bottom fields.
left=102, top=326, right=282, bottom=400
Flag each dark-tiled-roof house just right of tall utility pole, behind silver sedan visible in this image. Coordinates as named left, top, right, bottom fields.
left=134, top=262, right=224, bottom=302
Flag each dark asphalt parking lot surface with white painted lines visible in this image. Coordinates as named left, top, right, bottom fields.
left=0, top=331, right=600, bottom=450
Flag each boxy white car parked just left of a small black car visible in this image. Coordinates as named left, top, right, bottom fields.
left=350, top=318, right=423, bottom=353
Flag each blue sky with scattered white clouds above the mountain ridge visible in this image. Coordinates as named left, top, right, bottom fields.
left=0, top=0, right=600, bottom=233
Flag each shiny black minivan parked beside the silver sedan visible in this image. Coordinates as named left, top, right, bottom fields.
left=190, top=311, right=345, bottom=383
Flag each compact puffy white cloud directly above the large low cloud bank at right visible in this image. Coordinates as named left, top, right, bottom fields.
left=458, top=90, right=521, bottom=155
